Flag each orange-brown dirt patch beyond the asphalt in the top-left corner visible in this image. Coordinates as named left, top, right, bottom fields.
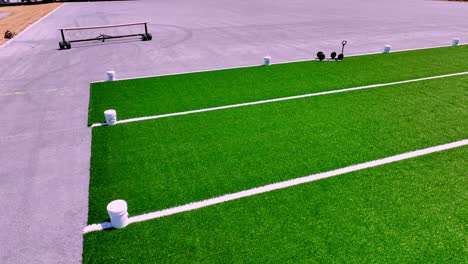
left=0, top=3, right=61, bottom=45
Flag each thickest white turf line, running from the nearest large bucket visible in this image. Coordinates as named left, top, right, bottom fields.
left=83, top=139, right=468, bottom=234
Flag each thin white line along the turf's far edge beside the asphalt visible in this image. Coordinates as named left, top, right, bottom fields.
left=91, top=43, right=468, bottom=83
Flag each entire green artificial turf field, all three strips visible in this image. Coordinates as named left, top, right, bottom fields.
left=83, top=46, right=468, bottom=263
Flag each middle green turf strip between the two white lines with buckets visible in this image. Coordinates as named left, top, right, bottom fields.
left=88, top=76, right=468, bottom=224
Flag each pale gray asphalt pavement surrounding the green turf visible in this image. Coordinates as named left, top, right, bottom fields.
left=0, top=0, right=468, bottom=263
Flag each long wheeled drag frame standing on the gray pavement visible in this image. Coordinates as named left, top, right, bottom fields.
left=59, top=22, right=153, bottom=49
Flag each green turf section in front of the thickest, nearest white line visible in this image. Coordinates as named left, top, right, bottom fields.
left=83, top=147, right=468, bottom=263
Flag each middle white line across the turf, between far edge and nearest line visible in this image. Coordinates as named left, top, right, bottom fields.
left=91, top=71, right=468, bottom=127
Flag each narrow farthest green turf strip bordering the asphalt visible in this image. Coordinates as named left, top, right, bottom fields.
left=88, top=46, right=468, bottom=124
